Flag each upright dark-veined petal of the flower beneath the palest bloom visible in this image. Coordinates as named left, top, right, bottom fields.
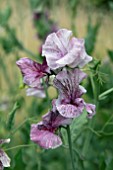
left=53, top=69, right=87, bottom=102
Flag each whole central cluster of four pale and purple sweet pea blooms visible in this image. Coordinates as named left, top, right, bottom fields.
left=17, top=29, right=95, bottom=149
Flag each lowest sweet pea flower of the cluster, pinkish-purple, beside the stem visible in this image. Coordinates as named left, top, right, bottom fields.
left=30, top=108, right=71, bottom=149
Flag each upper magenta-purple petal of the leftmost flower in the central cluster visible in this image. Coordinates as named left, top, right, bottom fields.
left=16, top=58, right=49, bottom=87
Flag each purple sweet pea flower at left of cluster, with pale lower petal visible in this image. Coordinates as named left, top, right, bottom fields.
left=16, top=58, right=50, bottom=98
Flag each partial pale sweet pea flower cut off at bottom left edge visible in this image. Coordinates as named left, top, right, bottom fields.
left=0, top=139, right=10, bottom=170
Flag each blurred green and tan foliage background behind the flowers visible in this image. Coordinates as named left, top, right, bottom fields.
left=0, top=0, right=113, bottom=170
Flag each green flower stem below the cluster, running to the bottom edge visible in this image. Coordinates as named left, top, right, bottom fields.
left=67, top=125, right=75, bottom=170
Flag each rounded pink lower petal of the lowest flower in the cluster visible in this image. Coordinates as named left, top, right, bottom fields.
left=30, top=124, right=62, bottom=149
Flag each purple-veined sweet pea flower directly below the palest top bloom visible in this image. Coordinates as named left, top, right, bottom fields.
left=54, top=69, right=95, bottom=118
